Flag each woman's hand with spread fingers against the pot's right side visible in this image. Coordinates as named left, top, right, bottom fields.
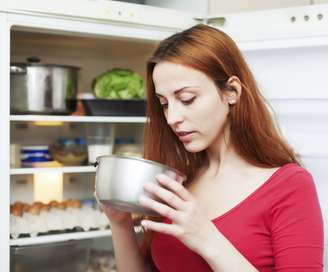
left=140, top=174, right=218, bottom=255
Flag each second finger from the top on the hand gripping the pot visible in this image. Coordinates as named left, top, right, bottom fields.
left=144, top=182, right=184, bottom=210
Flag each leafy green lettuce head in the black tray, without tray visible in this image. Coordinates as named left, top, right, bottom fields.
left=92, top=68, right=145, bottom=99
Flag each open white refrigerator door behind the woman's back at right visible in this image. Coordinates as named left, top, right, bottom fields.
left=208, top=4, right=328, bottom=265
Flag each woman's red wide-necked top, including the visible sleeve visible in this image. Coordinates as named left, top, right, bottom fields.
left=151, top=163, right=323, bottom=272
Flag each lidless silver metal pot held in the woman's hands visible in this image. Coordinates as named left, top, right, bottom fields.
left=95, top=155, right=186, bottom=215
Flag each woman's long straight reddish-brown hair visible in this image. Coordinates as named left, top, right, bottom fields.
left=145, top=24, right=298, bottom=181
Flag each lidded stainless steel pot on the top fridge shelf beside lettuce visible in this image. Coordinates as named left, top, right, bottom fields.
left=10, top=58, right=79, bottom=114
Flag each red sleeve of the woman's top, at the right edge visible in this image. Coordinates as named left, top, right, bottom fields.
left=271, top=170, right=324, bottom=272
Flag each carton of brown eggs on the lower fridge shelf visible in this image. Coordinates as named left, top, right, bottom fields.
left=10, top=199, right=108, bottom=240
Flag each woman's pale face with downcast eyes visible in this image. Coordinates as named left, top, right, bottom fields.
left=153, top=62, right=229, bottom=152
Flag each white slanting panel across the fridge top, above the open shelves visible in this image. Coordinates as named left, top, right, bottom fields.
left=0, top=0, right=196, bottom=30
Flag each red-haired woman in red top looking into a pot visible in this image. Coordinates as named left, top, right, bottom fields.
left=99, top=25, right=323, bottom=272
